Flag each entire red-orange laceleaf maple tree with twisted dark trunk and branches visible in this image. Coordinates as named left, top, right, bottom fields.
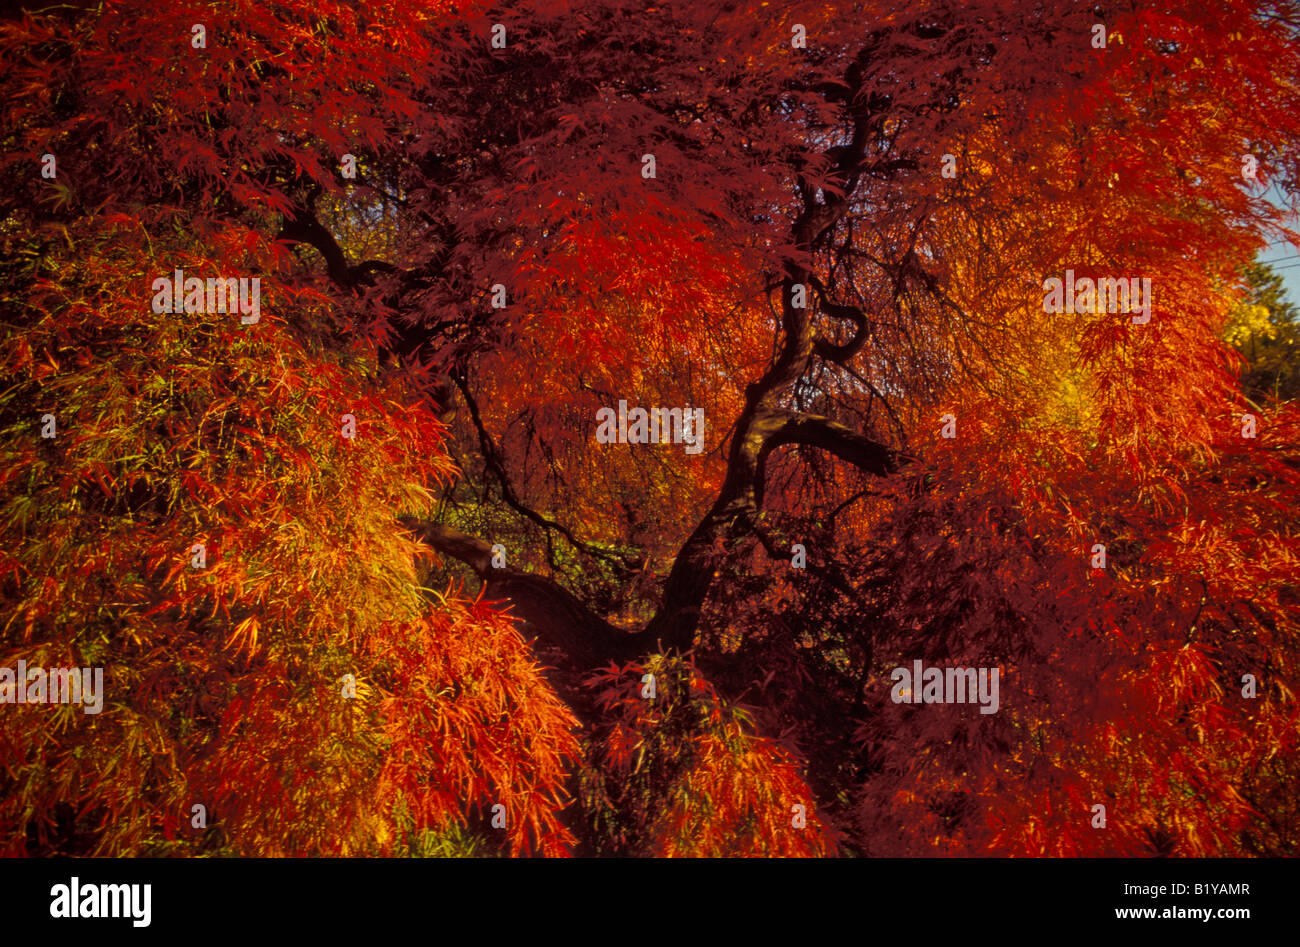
left=0, top=0, right=1300, bottom=857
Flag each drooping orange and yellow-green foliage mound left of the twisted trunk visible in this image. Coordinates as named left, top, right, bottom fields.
left=0, top=206, right=577, bottom=855
